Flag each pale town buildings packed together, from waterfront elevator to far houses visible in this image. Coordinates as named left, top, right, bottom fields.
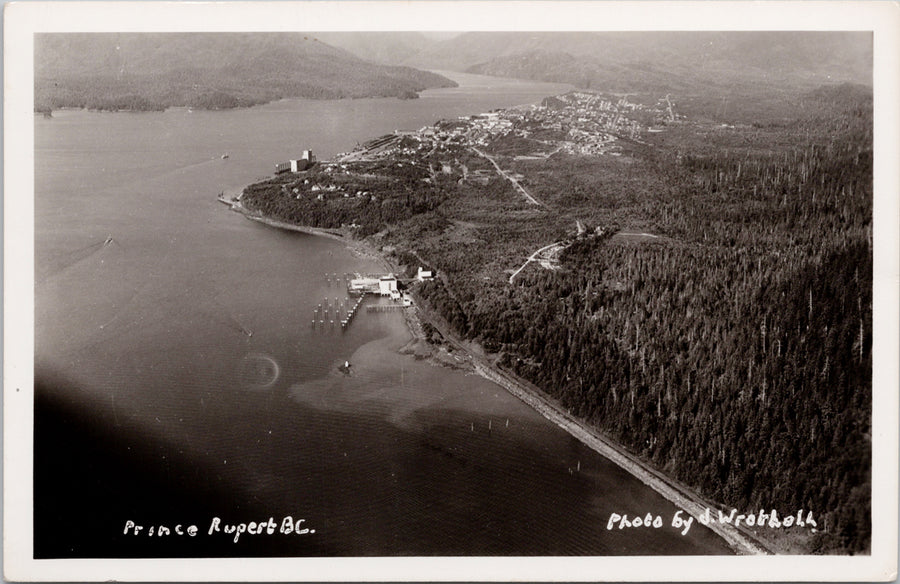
left=276, top=91, right=678, bottom=209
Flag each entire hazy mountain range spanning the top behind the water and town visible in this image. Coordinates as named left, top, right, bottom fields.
left=35, top=31, right=872, bottom=111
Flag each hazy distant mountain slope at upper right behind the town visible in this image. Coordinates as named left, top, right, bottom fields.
left=405, top=32, right=872, bottom=91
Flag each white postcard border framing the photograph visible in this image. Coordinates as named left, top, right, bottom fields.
left=3, top=1, right=900, bottom=581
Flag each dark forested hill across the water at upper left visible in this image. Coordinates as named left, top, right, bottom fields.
left=35, top=33, right=455, bottom=111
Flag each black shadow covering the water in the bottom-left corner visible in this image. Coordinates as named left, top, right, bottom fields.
left=34, top=373, right=336, bottom=559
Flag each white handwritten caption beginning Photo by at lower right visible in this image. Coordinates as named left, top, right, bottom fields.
left=606, top=507, right=816, bottom=535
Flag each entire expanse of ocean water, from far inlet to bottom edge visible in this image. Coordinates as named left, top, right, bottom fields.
left=34, top=74, right=729, bottom=558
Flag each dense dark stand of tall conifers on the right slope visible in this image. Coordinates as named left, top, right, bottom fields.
left=436, top=89, right=872, bottom=551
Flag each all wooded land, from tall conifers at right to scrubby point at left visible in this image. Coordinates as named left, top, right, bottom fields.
left=244, top=85, right=873, bottom=553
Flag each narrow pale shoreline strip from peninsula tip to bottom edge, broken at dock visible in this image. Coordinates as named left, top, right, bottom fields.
left=227, top=193, right=789, bottom=555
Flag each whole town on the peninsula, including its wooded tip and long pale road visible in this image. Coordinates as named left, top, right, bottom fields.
left=242, top=91, right=684, bottom=242
